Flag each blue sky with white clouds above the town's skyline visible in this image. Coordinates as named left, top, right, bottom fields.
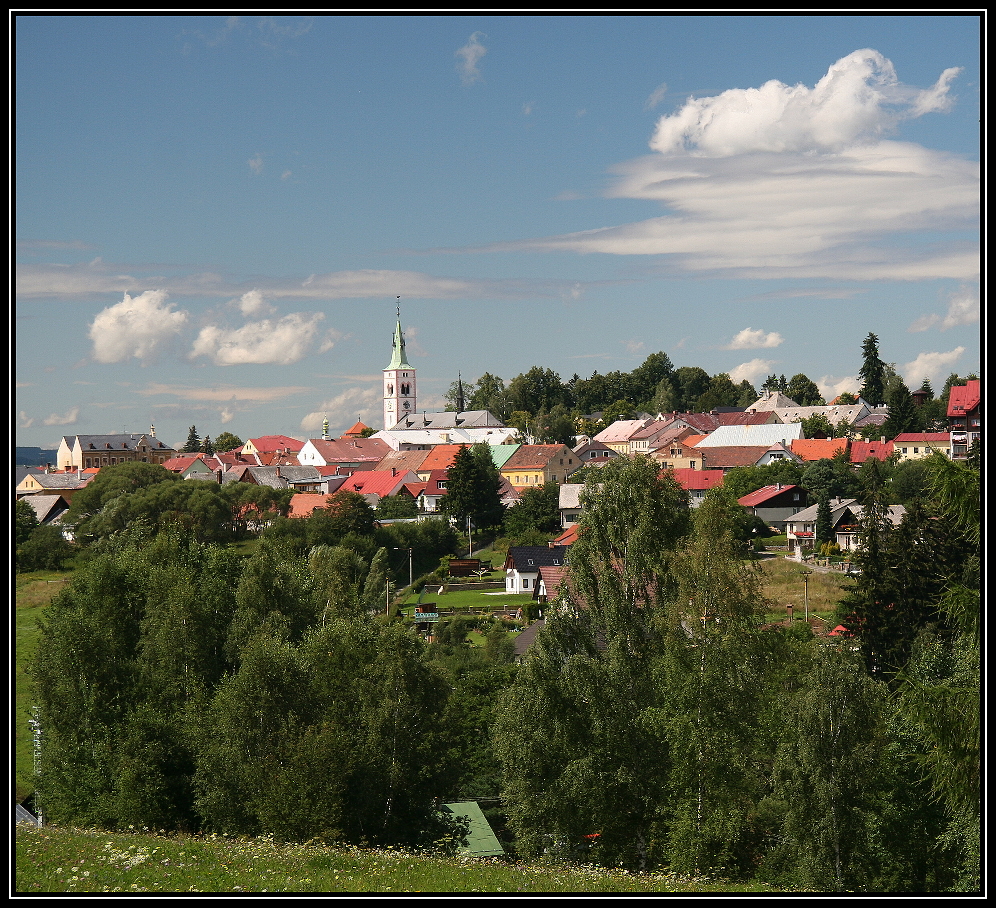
left=12, top=15, right=982, bottom=447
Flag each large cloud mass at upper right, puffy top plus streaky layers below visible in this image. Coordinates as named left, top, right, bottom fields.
left=476, top=51, right=980, bottom=281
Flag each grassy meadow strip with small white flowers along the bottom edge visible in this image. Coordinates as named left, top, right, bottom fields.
left=14, top=826, right=792, bottom=894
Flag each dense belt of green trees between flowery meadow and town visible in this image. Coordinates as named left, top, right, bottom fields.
left=23, top=450, right=981, bottom=892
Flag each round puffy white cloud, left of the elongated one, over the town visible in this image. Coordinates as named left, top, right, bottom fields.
left=90, top=290, right=187, bottom=363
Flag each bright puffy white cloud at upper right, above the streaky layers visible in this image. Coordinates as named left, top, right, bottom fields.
left=650, top=49, right=961, bottom=157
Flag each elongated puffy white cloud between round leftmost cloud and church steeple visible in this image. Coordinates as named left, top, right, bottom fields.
left=190, top=312, right=325, bottom=366
